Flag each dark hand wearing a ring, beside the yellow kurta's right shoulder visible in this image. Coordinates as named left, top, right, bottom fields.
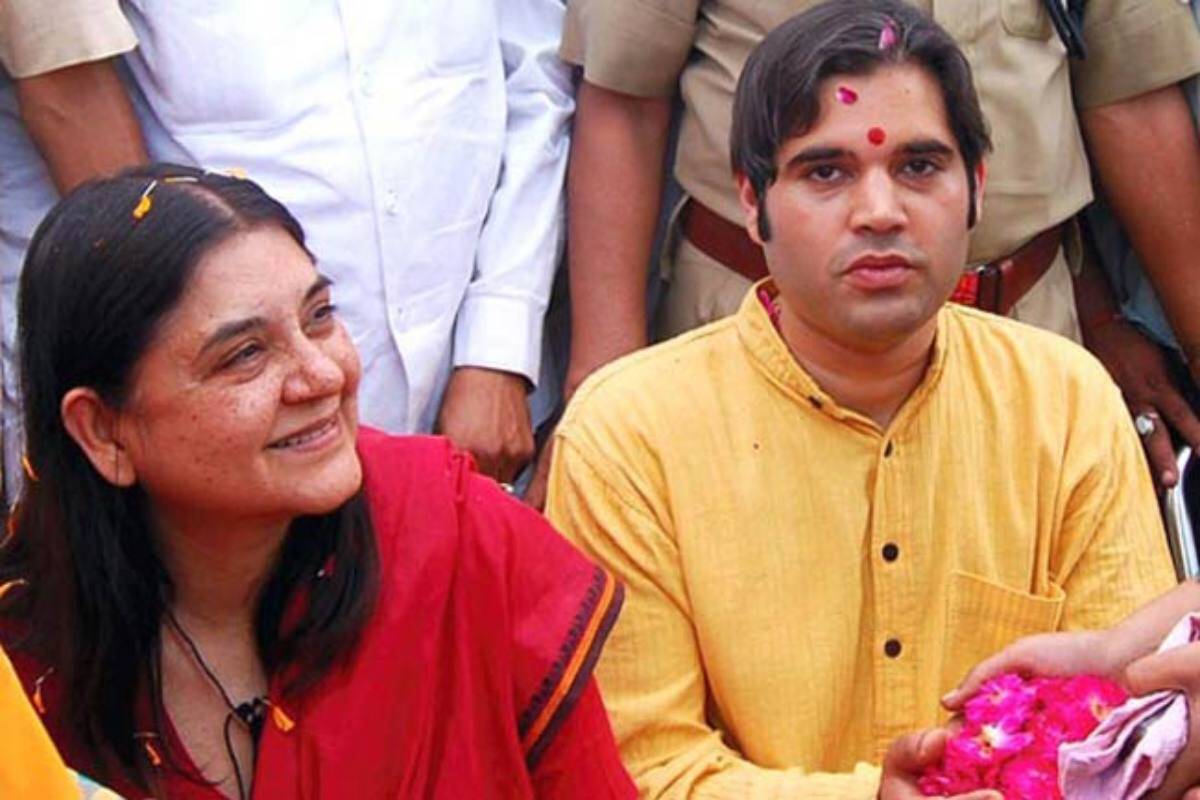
left=1084, top=320, right=1200, bottom=488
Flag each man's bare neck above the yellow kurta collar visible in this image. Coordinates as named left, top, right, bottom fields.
left=779, top=303, right=937, bottom=429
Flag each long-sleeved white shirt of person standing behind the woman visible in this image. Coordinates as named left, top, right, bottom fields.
left=122, top=0, right=574, bottom=432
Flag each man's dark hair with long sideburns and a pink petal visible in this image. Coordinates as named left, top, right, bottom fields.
left=730, top=0, right=991, bottom=240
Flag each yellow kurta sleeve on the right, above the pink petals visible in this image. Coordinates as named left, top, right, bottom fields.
left=1051, top=375, right=1176, bottom=630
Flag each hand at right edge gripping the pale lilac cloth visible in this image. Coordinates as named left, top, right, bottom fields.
left=1126, top=643, right=1200, bottom=800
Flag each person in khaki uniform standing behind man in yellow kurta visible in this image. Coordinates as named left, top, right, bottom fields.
left=562, top=0, right=1200, bottom=494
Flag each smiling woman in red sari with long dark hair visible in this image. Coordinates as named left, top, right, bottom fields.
left=0, top=166, right=634, bottom=800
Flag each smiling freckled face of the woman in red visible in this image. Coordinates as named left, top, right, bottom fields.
left=116, top=227, right=362, bottom=523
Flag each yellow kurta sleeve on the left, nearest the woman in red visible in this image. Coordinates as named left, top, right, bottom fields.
left=546, top=434, right=880, bottom=800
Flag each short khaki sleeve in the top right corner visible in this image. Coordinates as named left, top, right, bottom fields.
left=1072, top=0, right=1200, bottom=108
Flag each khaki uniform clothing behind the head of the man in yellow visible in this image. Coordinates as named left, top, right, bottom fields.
left=560, top=0, right=1200, bottom=338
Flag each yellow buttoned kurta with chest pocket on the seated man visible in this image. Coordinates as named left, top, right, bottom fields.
left=547, top=291, right=1175, bottom=800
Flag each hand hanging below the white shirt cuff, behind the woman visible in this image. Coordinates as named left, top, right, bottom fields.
left=434, top=367, right=533, bottom=483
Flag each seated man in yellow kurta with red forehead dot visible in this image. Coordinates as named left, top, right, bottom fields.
left=547, top=0, right=1174, bottom=800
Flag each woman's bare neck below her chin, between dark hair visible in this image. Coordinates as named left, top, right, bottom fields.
left=158, top=521, right=287, bottom=632
